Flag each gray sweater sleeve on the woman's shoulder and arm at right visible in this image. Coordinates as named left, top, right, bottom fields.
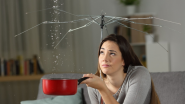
left=123, top=68, right=151, bottom=104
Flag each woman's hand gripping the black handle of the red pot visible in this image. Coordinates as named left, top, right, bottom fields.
left=81, top=74, right=106, bottom=90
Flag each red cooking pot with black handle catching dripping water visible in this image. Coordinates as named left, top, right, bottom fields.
left=42, top=77, right=89, bottom=95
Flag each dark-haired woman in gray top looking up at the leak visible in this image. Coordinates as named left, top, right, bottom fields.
left=82, top=34, right=151, bottom=104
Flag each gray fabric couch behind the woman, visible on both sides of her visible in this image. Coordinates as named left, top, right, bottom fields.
left=37, top=71, right=185, bottom=104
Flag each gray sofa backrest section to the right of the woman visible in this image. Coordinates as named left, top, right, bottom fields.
left=151, top=71, right=185, bottom=104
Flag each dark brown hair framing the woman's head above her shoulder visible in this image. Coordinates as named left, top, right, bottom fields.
left=96, top=34, right=142, bottom=78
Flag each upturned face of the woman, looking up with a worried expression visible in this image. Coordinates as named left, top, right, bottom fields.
left=99, top=41, right=125, bottom=75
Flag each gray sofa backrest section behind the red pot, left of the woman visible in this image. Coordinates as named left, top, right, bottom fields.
left=37, top=73, right=90, bottom=104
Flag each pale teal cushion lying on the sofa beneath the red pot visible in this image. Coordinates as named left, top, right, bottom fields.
left=21, top=88, right=83, bottom=104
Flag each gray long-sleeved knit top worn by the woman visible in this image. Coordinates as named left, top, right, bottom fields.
left=88, top=66, right=151, bottom=104
